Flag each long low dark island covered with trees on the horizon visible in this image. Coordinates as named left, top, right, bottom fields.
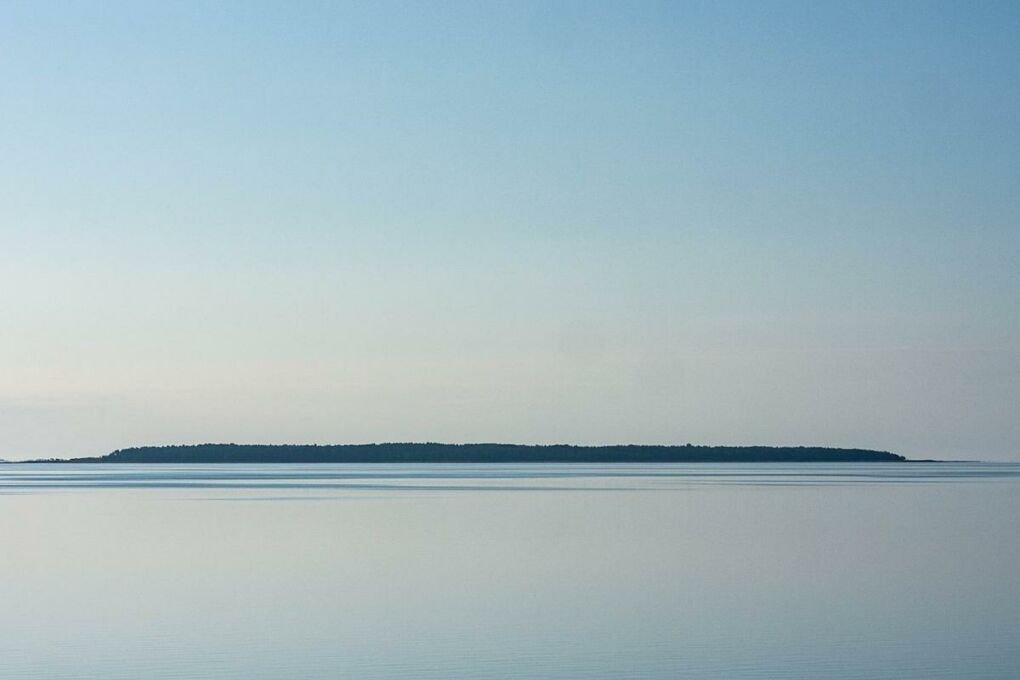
left=54, top=442, right=907, bottom=463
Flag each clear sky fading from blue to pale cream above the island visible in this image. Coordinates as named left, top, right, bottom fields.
left=0, top=0, right=1020, bottom=460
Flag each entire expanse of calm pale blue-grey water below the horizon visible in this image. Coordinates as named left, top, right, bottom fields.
left=0, top=464, right=1020, bottom=680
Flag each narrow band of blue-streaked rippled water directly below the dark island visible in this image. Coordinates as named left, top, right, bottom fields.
left=0, top=463, right=1020, bottom=491
